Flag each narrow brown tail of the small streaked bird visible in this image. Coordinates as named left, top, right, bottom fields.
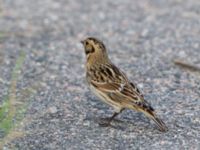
left=140, top=108, right=168, bottom=132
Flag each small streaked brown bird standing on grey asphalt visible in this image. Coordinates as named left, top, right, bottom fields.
left=81, top=37, right=168, bottom=132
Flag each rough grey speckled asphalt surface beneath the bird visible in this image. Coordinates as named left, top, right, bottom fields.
left=0, top=0, right=200, bottom=150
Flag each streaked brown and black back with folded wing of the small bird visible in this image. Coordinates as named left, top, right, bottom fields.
left=90, top=64, right=144, bottom=103
